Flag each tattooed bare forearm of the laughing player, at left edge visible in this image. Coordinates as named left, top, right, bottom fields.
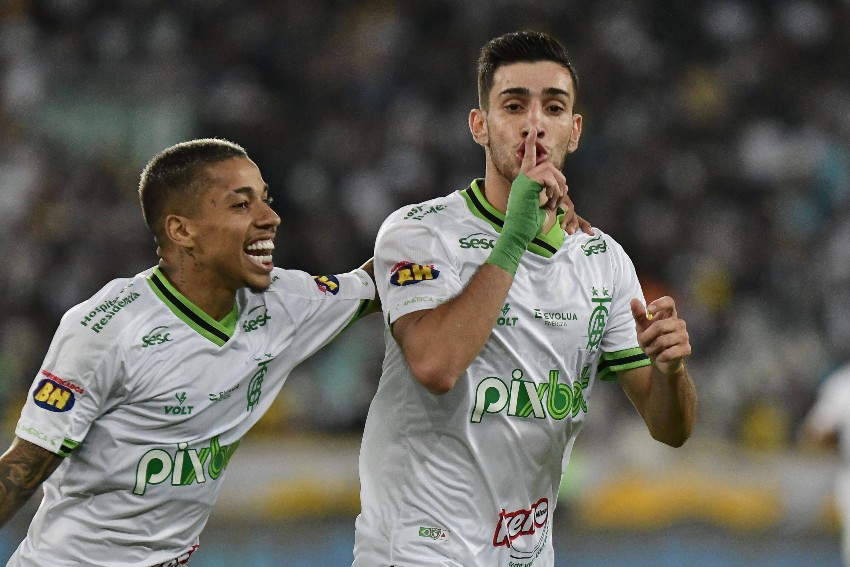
left=0, top=437, right=62, bottom=528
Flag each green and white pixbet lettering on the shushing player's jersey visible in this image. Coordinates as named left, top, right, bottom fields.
left=470, top=366, right=590, bottom=423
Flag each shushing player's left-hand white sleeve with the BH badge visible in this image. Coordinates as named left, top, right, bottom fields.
left=375, top=215, right=463, bottom=324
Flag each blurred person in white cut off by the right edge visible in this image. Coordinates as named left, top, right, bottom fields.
left=800, top=363, right=850, bottom=567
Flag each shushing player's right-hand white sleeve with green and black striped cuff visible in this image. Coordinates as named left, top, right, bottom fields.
left=597, top=235, right=650, bottom=380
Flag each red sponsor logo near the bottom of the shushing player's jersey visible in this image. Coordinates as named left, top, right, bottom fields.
left=493, top=498, right=549, bottom=566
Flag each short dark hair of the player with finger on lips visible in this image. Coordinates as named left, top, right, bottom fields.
left=478, top=30, right=578, bottom=110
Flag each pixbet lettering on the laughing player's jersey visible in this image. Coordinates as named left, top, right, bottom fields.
left=133, top=436, right=239, bottom=495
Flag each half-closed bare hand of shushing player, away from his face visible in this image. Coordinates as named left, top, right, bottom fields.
left=631, top=296, right=691, bottom=376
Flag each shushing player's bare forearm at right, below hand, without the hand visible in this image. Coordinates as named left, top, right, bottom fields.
left=644, top=364, right=697, bottom=447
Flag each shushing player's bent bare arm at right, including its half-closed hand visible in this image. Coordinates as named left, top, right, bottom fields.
left=619, top=297, right=697, bottom=447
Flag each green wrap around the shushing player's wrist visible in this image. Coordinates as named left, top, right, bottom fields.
left=486, top=173, right=546, bottom=275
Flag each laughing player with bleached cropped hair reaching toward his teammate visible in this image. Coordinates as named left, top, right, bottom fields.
left=0, top=139, right=375, bottom=567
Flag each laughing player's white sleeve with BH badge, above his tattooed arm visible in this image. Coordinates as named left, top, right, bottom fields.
left=15, top=310, right=124, bottom=457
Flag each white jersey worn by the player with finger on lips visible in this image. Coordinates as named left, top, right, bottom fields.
left=354, top=182, right=649, bottom=567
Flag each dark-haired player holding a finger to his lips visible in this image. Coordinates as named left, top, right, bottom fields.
left=354, top=32, right=696, bottom=567
